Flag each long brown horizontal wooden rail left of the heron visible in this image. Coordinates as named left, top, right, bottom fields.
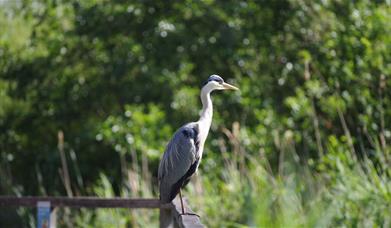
left=0, top=196, right=170, bottom=208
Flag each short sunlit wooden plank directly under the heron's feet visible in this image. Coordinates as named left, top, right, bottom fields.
left=172, top=197, right=205, bottom=228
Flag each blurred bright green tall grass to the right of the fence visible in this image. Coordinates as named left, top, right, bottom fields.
left=188, top=143, right=391, bottom=227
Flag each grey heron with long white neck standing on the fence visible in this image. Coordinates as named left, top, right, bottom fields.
left=158, top=75, right=238, bottom=214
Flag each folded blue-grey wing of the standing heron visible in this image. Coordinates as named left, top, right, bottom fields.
left=158, top=124, right=199, bottom=202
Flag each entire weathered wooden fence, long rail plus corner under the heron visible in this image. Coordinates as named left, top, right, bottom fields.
left=0, top=196, right=204, bottom=228
